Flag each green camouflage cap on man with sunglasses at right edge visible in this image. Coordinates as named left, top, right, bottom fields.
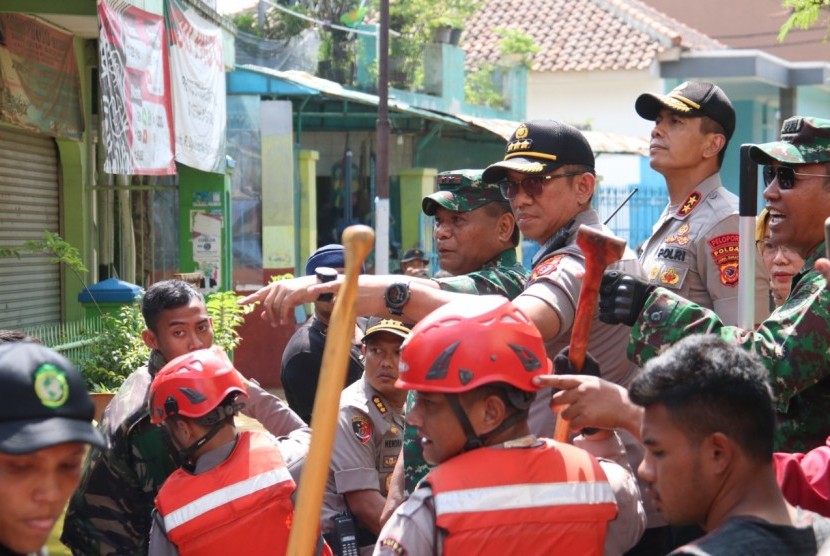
left=749, top=116, right=830, bottom=164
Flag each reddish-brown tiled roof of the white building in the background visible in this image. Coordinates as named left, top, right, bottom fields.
left=462, top=0, right=725, bottom=72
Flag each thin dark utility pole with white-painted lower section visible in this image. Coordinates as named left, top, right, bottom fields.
left=375, top=0, right=390, bottom=274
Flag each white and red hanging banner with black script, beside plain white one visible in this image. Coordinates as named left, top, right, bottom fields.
left=98, top=0, right=176, bottom=175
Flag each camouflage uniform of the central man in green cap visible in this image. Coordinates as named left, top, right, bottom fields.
left=403, top=249, right=530, bottom=494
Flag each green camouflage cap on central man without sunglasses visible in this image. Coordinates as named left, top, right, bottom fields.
left=421, top=170, right=508, bottom=216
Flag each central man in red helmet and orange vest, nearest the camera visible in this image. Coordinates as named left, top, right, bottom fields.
left=375, top=296, right=645, bottom=555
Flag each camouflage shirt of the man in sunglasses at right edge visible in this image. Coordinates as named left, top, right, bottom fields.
left=628, top=244, right=830, bottom=452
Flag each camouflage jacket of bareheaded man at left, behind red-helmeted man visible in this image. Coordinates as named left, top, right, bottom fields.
left=61, top=351, right=179, bottom=555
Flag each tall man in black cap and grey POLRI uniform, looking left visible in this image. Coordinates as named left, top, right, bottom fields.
left=635, top=81, right=769, bottom=324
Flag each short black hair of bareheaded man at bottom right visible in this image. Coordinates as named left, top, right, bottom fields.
left=628, top=334, right=775, bottom=462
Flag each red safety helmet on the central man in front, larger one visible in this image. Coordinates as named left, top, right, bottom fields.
left=395, top=295, right=553, bottom=394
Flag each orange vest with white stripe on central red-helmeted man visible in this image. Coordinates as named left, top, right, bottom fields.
left=425, top=439, right=617, bottom=556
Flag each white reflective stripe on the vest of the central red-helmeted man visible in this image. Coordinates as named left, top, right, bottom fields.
left=435, top=482, right=615, bottom=516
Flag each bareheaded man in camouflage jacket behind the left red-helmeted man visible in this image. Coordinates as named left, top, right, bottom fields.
left=61, top=280, right=311, bottom=555
